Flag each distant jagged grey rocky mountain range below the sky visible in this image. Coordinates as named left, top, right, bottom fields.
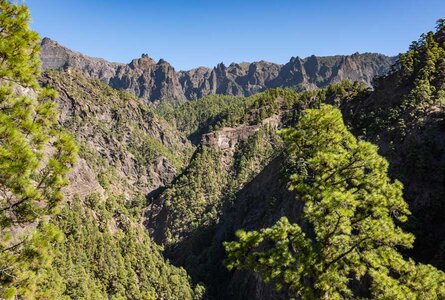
left=41, top=38, right=396, bottom=102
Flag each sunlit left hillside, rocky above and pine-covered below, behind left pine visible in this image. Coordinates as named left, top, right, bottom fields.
left=40, top=70, right=202, bottom=299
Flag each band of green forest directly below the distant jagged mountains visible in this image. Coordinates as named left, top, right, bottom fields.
left=155, top=81, right=369, bottom=143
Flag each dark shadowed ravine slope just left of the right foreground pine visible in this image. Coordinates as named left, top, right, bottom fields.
left=163, top=155, right=302, bottom=299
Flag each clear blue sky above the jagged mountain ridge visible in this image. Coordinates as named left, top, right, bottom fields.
left=25, top=0, right=445, bottom=70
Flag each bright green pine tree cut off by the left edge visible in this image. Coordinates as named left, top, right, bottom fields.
left=0, top=0, right=76, bottom=298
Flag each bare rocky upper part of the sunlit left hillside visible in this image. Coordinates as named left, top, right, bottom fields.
left=40, top=70, right=193, bottom=198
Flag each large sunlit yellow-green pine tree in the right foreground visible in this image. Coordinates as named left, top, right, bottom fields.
left=225, top=105, right=445, bottom=299
